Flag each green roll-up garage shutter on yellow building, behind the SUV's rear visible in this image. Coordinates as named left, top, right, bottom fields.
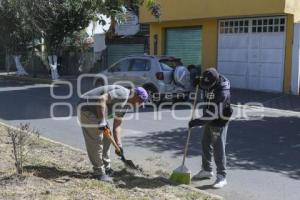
left=165, top=27, right=202, bottom=65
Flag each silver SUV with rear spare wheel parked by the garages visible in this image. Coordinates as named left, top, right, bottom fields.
left=93, top=55, right=192, bottom=102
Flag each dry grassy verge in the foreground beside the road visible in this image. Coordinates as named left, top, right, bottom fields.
left=0, top=126, right=219, bottom=200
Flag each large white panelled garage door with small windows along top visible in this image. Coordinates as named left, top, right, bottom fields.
left=218, top=17, right=286, bottom=92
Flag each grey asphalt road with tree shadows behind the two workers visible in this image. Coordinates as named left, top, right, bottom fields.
left=0, top=80, right=300, bottom=200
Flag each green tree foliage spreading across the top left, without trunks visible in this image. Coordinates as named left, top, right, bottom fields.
left=0, top=0, right=159, bottom=53
